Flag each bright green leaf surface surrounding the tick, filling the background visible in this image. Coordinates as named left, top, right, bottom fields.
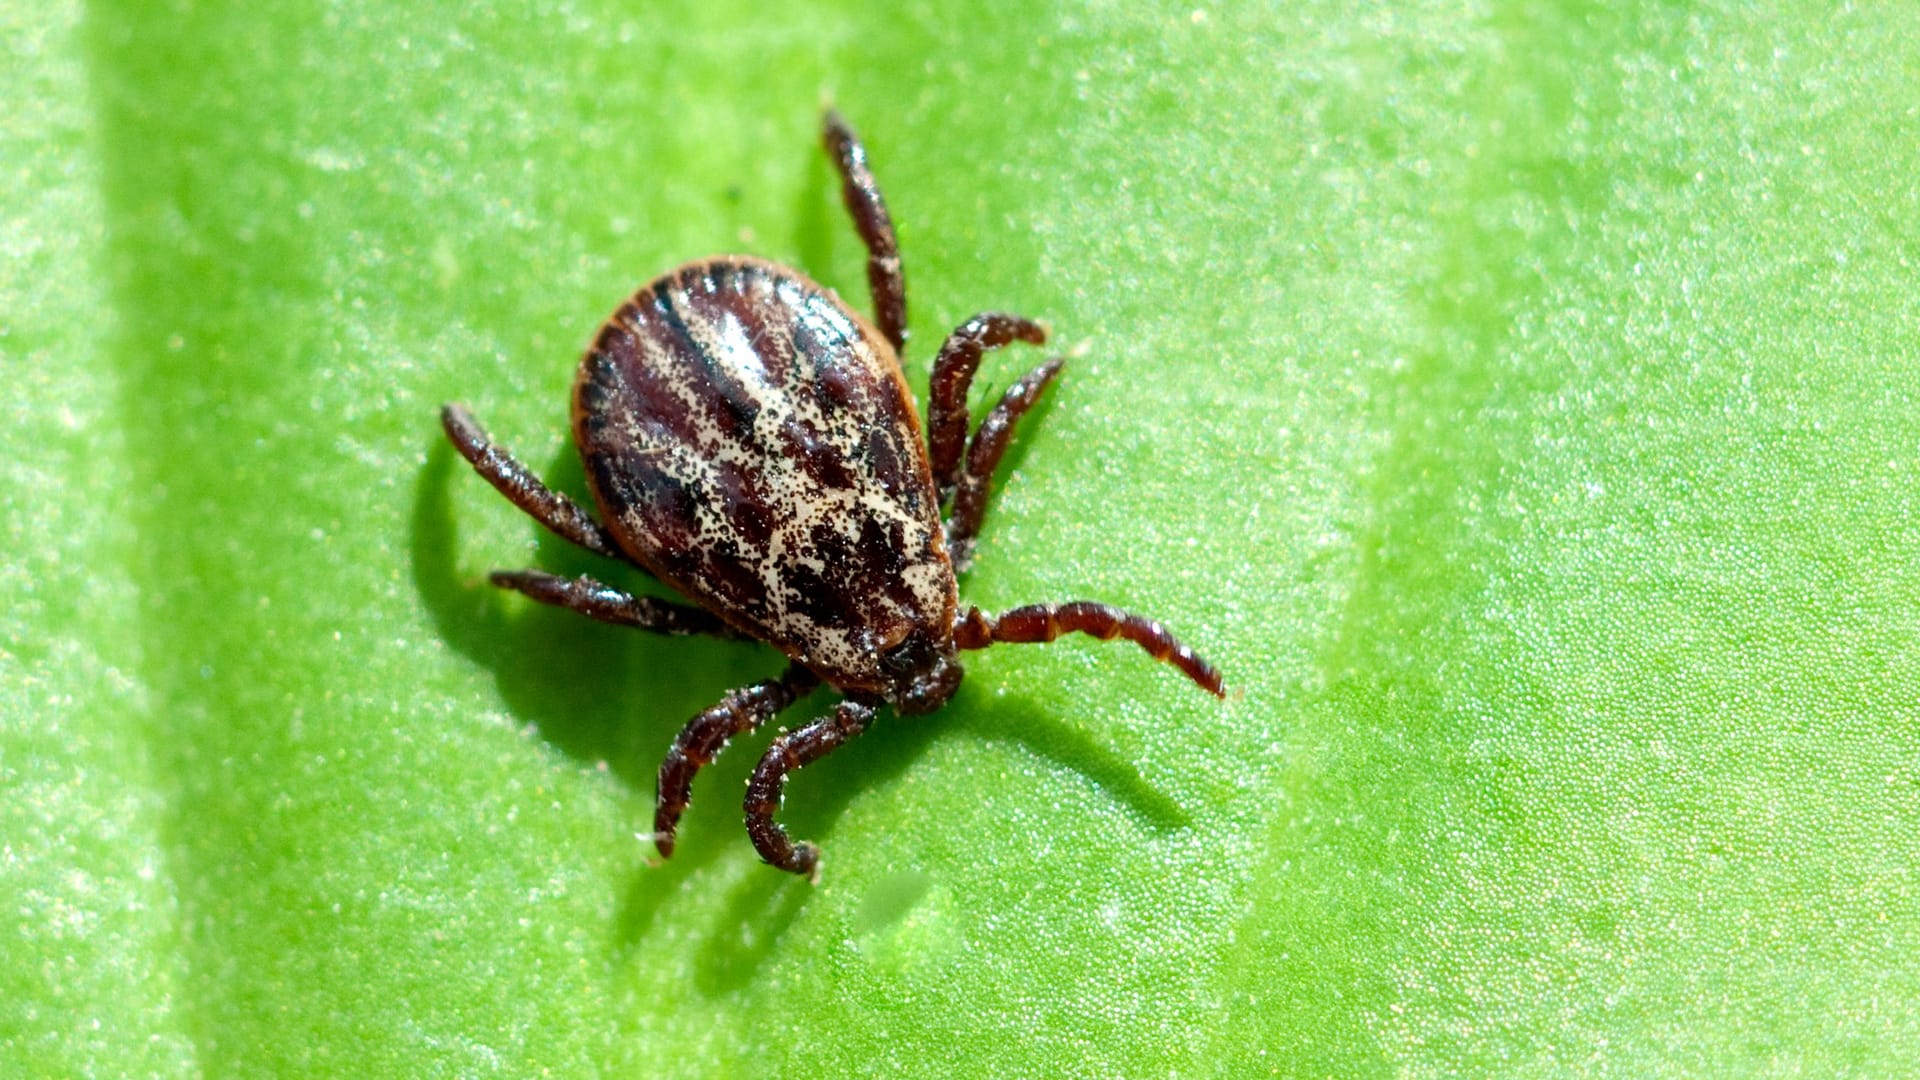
left=0, top=0, right=1920, bottom=1076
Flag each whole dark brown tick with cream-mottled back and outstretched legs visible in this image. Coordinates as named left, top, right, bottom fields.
left=440, top=111, right=1221, bottom=874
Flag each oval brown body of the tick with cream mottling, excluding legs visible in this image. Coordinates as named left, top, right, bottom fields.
left=574, top=258, right=958, bottom=692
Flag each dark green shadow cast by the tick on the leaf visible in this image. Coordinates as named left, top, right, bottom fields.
left=411, top=432, right=1190, bottom=960
